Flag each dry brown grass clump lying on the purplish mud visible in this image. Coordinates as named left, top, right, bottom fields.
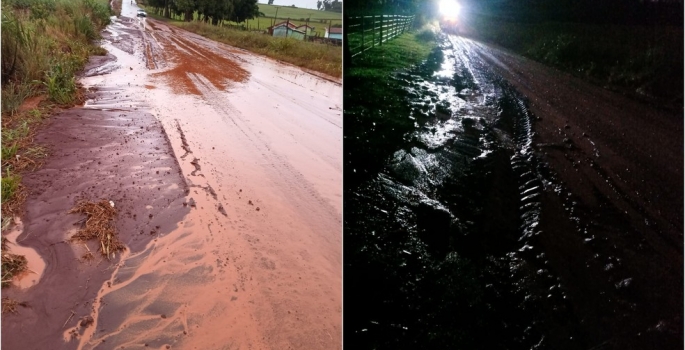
left=69, top=200, right=126, bottom=259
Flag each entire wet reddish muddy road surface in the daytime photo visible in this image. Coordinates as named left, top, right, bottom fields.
left=2, top=1, right=342, bottom=349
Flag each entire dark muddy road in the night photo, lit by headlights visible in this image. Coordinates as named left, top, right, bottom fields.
left=344, top=36, right=683, bottom=349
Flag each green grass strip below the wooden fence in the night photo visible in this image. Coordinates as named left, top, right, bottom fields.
left=343, top=25, right=442, bottom=188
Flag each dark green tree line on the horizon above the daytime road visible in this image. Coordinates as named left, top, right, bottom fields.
left=146, top=0, right=261, bottom=25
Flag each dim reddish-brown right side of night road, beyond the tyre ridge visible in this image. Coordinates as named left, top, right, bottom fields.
left=460, top=39, right=683, bottom=349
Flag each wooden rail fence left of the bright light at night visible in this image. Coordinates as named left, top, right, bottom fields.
left=343, top=15, right=414, bottom=57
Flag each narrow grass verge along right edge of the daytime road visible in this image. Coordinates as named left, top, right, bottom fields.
left=148, top=14, right=342, bottom=78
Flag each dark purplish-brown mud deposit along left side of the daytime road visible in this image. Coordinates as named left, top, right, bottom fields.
left=2, top=56, right=188, bottom=349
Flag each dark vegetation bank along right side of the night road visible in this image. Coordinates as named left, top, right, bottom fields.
left=471, top=17, right=683, bottom=106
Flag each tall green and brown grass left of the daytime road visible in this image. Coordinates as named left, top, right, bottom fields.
left=1, top=0, right=110, bottom=108
